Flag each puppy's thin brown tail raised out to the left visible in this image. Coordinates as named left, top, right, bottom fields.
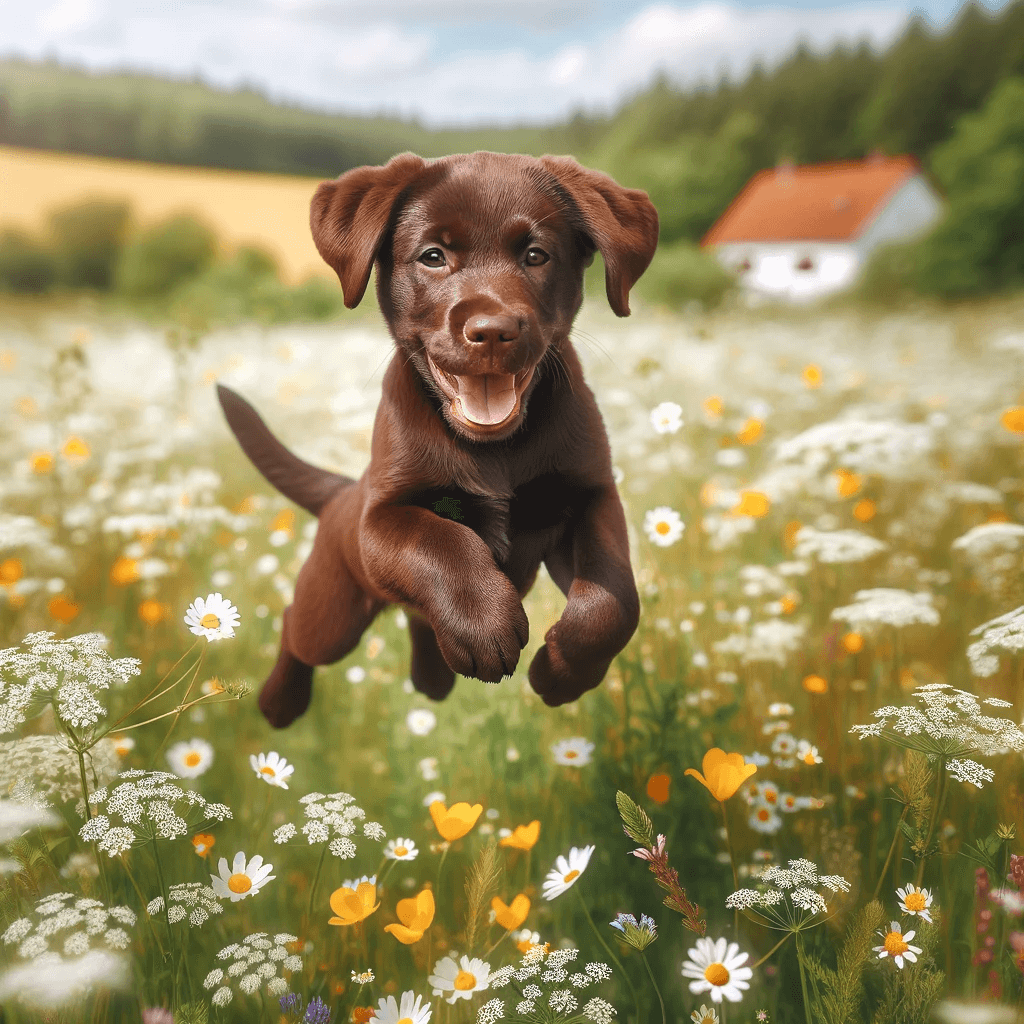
left=217, top=384, right=354, bottom=516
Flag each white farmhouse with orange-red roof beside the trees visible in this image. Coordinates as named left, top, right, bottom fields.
left=700, top=154, right=943, bottom=302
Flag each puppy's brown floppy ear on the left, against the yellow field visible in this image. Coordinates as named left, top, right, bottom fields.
left=309, top=153, right=427, bottom=309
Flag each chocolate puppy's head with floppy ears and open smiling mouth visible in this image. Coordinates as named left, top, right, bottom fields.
left=310, top=153, right=657, bottom=441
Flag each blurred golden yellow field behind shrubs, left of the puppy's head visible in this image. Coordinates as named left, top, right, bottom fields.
left=0, top=145, right=332, bottom=284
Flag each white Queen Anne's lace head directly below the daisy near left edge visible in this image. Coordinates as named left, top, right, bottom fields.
left=79, top=769, right=231, bottom=857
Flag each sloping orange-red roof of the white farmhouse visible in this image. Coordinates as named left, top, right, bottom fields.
left=700, top=156, right=921, bottom=246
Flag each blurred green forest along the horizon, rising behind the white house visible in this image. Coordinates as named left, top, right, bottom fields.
left=0, top=0, right=1024, bottom=302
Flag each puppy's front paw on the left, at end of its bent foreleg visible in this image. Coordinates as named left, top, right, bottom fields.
left=434, top=584, right=529, bottom=683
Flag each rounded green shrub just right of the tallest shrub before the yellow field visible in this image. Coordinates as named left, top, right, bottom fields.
left=116, top=214, right=217, bottom=299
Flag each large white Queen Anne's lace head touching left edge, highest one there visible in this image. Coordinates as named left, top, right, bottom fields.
left=0, top=630, right=140, bottom=738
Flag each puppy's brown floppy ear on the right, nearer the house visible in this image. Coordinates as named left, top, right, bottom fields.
left=541, top=157, right=657, bottom=316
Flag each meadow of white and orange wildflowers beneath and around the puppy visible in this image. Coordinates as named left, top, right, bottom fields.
left=0, top=292, right=1024, bottom=1024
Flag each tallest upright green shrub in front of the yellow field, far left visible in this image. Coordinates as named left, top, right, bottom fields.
left=50, top=200, right=131, bottom=291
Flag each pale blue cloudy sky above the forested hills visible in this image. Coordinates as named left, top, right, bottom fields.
left=0, top=0, right=1002, bottom=125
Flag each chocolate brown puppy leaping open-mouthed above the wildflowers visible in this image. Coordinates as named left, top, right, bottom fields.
left=218, top=153, right=657, bottom=727
